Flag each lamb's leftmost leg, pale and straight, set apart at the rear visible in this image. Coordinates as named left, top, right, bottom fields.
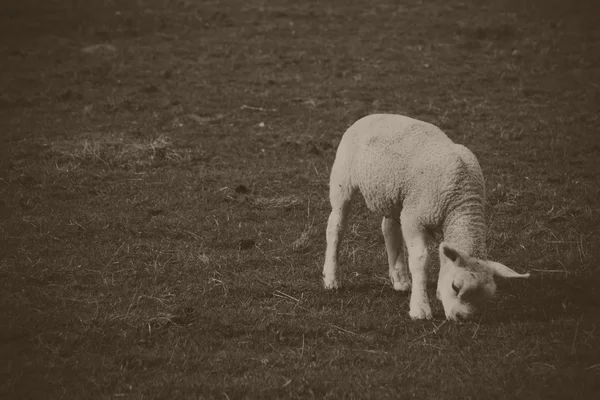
left=323, top=179, right=354, bottom=289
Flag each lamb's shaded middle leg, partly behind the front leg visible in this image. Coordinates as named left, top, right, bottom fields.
left=381, top=213, right=410, bottom=291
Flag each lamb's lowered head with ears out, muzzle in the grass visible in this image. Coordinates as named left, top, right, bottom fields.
left=437, top=242, right=529, bottom=320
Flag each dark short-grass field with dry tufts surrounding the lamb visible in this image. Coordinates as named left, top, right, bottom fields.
left=0, top=0, right=600, bottom=399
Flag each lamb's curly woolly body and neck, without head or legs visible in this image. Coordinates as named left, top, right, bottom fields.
left=332, top=114, right=486, bottom=257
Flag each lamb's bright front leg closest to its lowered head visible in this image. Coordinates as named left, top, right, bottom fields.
left=401, top=212, right=432, bottom=319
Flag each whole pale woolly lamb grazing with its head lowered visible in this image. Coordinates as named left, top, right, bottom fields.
left=323, top=114, right=529, bottom=320
